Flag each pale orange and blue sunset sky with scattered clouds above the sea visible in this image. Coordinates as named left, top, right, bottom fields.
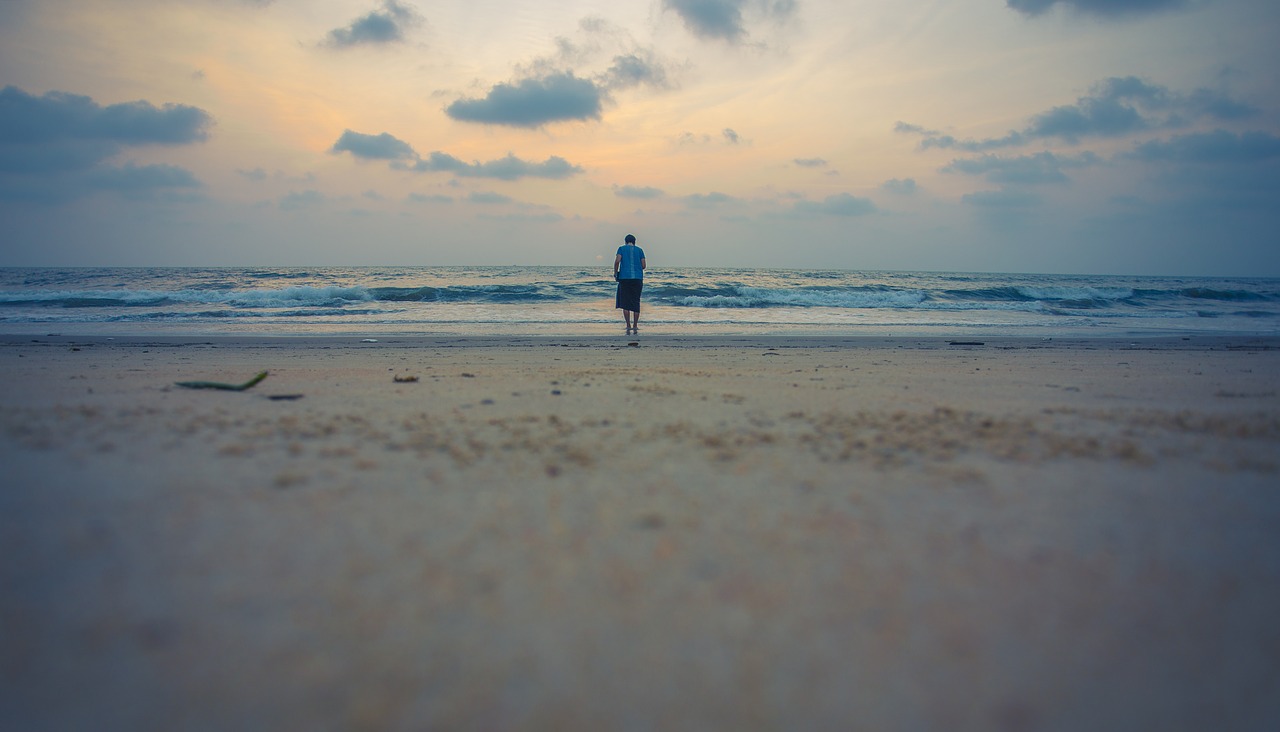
left=0, top=0, right=1280, bottom=276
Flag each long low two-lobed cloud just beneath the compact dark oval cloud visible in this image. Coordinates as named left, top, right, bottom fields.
left=330, top=129, right=582, bottom=180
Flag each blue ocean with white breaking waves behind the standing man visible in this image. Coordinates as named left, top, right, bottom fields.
left=0, top=266, right=1280, bottom=337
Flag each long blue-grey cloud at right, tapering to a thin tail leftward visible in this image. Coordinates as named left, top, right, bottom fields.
left=893, top=77, right=1257, bottom=152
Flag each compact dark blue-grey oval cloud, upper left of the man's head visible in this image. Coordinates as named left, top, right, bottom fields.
left=444, top=72, right=605, bottom=127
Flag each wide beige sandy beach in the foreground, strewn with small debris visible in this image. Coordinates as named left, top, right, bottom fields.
left=0, top=334, right=1280, bottom=731
